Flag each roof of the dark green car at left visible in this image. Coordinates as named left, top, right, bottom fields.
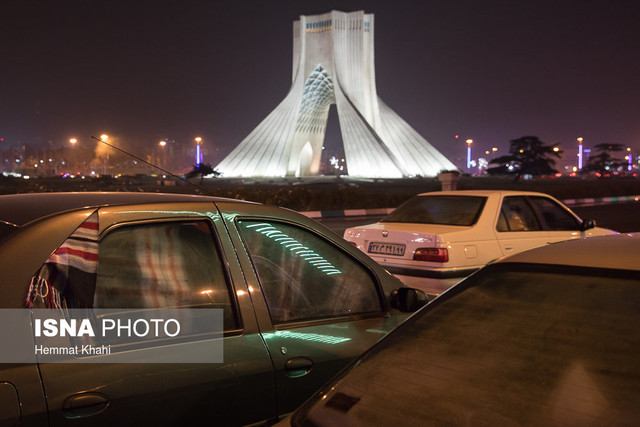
left=0, top=192, right=248, bottom=226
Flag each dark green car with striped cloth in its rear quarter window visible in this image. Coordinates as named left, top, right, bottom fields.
left=0, top=193, right=424, bottom=425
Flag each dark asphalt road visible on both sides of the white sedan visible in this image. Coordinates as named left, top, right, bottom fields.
left=319, top=203, right=640, bottom=236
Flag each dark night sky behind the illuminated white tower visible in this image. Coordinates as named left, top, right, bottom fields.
left=0, top=0, right=640, bottom=170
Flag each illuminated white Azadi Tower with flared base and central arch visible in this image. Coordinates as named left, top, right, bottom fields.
left=216, top=11, right=456, bottom=178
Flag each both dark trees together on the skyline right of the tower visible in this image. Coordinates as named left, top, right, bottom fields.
left=487, top=136, right=627, bottom=179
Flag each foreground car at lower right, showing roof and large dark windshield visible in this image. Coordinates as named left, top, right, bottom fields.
left=283, top=235, right=640, bottom=426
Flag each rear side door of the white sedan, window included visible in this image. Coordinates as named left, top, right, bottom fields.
left=496, top=196, right=549, bottom=255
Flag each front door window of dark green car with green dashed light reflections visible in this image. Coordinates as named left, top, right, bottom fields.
left=238, top=220, right=381, bottom=323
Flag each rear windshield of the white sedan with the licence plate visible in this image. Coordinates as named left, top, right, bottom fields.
left=382, top=196, right=486, bottom=226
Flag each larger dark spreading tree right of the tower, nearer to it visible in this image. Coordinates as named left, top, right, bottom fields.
left=487, top=136, right=562, bottom=180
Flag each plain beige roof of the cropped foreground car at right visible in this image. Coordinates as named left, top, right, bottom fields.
left=497, top=234, right=640, bottom=270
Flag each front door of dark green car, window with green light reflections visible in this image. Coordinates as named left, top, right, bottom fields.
left=218, top=204, right=403, bottom=415
